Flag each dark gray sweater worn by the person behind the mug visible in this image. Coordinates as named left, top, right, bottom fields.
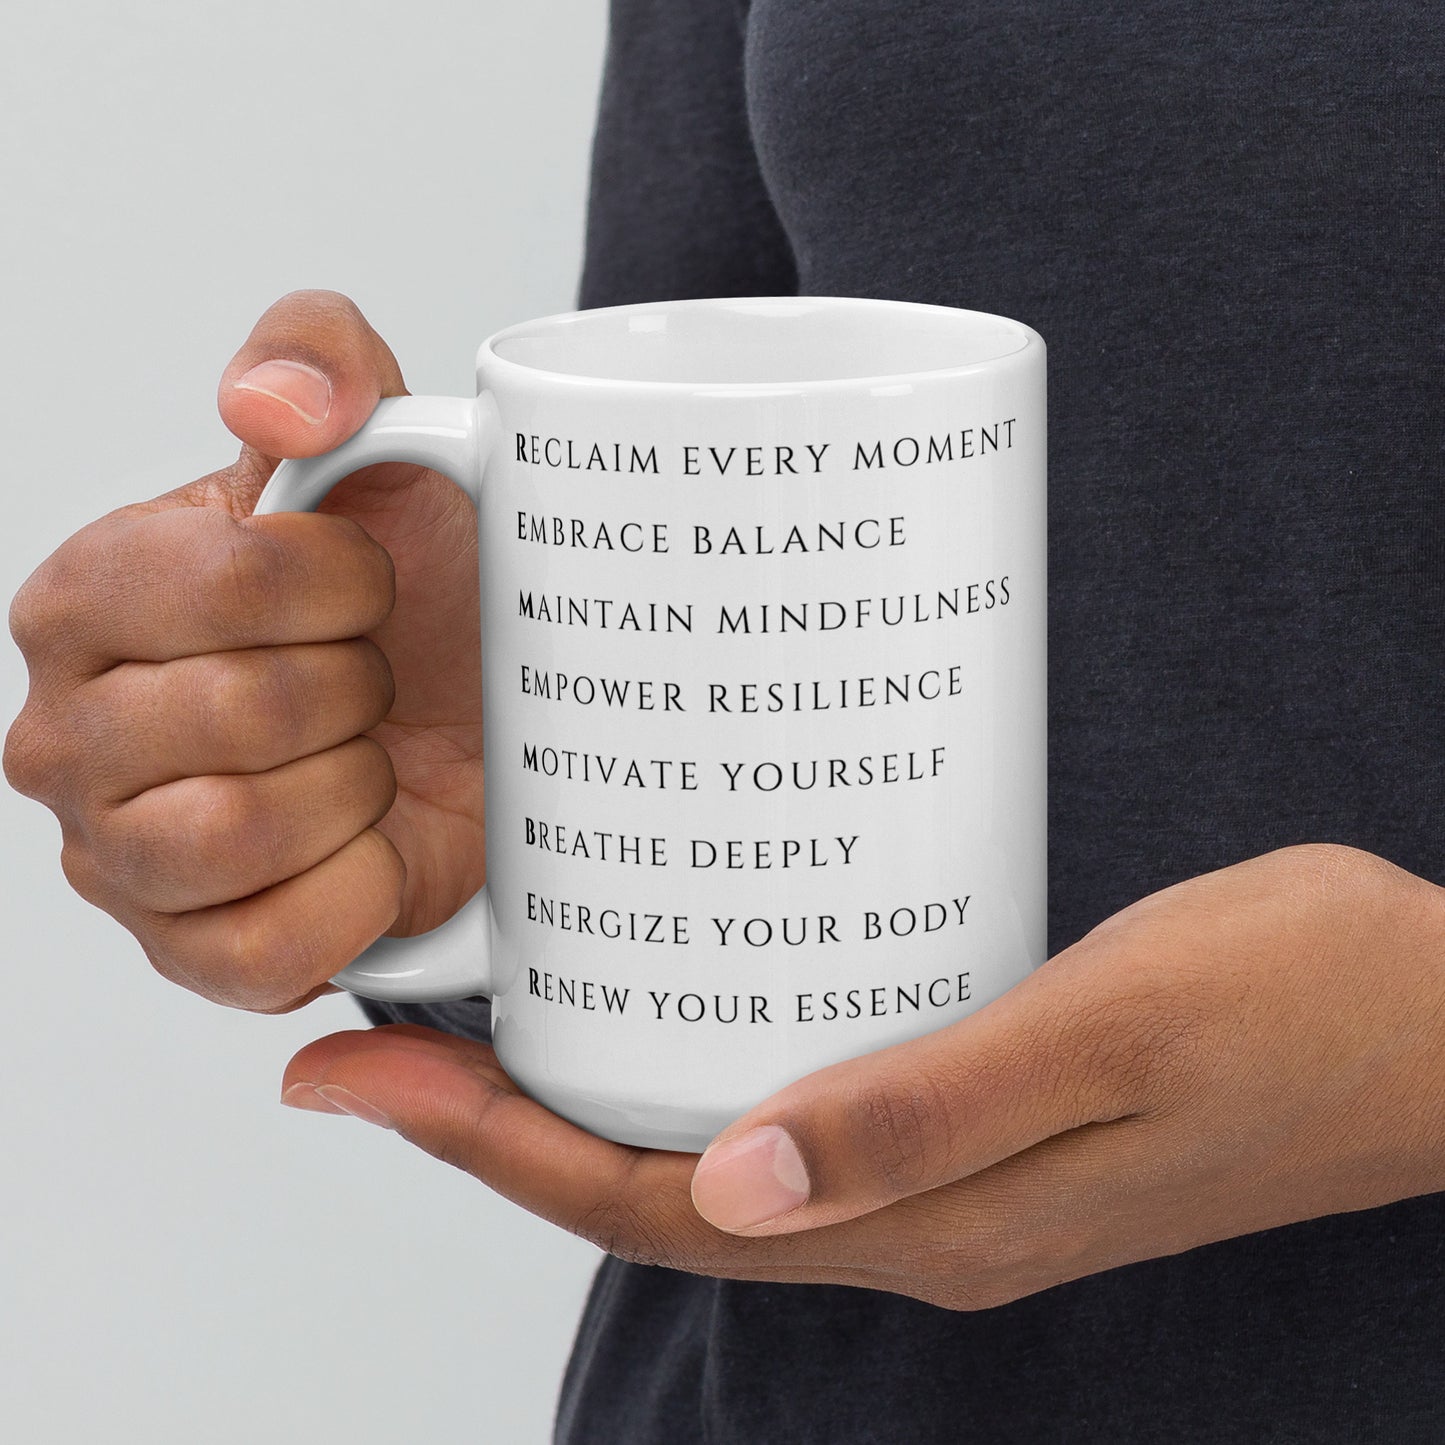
left=368, top=0, right=1445, bottom=1445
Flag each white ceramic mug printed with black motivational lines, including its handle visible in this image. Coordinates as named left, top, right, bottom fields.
left=256, top=296, right=1048, bottom=1150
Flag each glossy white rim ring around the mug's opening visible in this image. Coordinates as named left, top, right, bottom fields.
left=477, top=295, right=1045, bottom=396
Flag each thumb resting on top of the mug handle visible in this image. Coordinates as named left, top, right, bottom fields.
left=217, top=290, right=406, bottom=500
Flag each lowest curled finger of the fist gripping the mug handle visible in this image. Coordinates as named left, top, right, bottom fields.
left=143, top=828, right=406, bottom=1013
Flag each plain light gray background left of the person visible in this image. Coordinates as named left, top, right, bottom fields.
left=0, top=0, right=605, bottom=1445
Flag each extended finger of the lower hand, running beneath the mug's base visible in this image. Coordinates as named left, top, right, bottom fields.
left=283, top=1025, right=842, bottom=1282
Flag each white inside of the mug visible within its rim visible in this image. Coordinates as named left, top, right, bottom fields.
left=481, top=296, right=1033, bottom=386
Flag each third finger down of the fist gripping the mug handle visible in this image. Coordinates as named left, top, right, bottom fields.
left=91, top=737, right=396, bottom=913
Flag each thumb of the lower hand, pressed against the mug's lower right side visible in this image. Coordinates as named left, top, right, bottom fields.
left=692, top=945, right=1140, bottom=1234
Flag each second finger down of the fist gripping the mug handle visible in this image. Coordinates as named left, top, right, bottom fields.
left=75, top=637, right=394, bottom=805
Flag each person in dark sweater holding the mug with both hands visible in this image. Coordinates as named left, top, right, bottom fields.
left=6, top=0, right=1445, bottom=1442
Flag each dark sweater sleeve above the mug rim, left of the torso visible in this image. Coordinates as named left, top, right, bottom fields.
left=357, top=0, right=796, bottom=1039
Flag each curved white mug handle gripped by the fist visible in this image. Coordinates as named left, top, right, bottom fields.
left=256, top=396, right=499, bottom=1003
